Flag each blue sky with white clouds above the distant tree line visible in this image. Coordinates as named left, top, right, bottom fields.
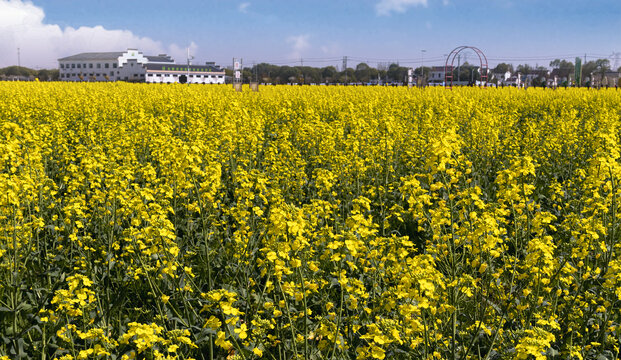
left=0, top=0, right=621, bottom=67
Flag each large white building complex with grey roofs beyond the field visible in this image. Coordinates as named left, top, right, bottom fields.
left=58, top=49, right=224, bottom=84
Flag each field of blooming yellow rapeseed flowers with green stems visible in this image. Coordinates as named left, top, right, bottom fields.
left=0, top=83, right=621, bottom=360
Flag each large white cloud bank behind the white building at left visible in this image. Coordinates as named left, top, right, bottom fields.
left=0, top=0, right=197, bottom=68
